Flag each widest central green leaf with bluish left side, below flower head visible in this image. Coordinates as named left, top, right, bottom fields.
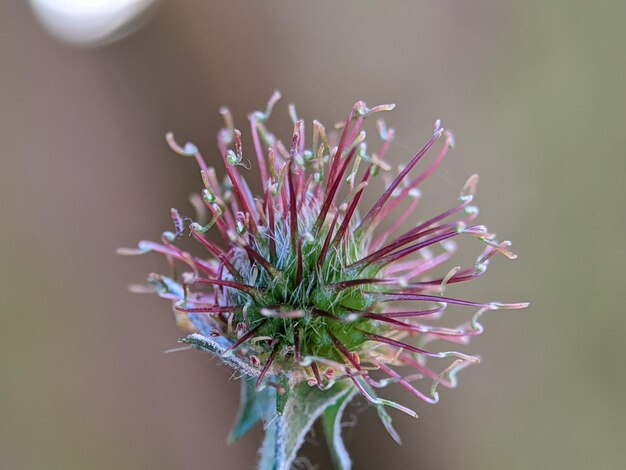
left=259, top=381, right=354, bottom=470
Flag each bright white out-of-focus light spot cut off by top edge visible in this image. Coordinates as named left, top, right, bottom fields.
left=29, top=0, right=156, bottom=46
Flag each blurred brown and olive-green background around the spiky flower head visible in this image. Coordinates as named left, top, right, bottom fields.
left=0, top=0, right=626, bottom=470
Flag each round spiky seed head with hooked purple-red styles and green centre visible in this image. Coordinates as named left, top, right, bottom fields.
left=121, top=92, right=527, bottom=468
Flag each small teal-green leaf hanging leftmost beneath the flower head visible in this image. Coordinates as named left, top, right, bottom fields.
left=228, top=377, right=276, bottom=444
